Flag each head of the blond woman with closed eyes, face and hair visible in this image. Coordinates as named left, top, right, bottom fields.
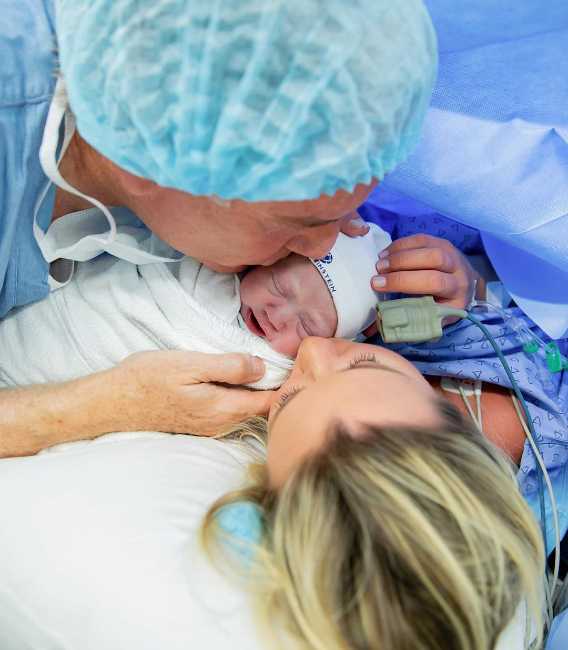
left=203, top=339, right=544, bottom=650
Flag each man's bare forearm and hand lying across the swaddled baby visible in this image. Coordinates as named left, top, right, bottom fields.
left=0, top=351, right=274, bottom=458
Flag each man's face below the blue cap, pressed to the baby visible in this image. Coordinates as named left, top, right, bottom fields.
left=129, top=181, right=377, bottom=272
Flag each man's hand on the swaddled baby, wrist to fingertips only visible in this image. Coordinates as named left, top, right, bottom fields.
left=110, top=350, right=273, bottom=436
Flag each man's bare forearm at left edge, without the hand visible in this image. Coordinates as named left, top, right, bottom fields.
left=0, top=371, right=123, bottom=458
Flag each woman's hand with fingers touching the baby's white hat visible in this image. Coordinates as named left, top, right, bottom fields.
left=371, top=235, right=480, bottom=309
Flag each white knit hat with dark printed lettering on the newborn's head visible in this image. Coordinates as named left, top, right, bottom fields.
left=311, top=224, right=392, bottom=339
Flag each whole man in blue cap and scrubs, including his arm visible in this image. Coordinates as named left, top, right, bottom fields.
left=0, top=0, right=444, bottom=456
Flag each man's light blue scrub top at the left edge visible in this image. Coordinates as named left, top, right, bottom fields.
left=0, top=0, right=56, bottom=318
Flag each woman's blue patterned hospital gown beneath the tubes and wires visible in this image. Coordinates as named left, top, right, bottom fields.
left=360, top=205, right=568, bottom=551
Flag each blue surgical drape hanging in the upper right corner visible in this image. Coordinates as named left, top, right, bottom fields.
left=374, top=0, right=568, bottom=338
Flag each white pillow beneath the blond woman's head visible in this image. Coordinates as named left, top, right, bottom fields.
left=0, top=433, right=261, bottom=650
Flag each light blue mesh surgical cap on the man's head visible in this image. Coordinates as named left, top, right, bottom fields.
left=56, top=0, right=437, bottom=201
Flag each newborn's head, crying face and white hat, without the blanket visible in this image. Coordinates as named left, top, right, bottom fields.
left=240, top=224, right=390, bottom=357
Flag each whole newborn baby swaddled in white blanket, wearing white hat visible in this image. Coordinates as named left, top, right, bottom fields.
left=0, top=220, right=390, bottom=388
